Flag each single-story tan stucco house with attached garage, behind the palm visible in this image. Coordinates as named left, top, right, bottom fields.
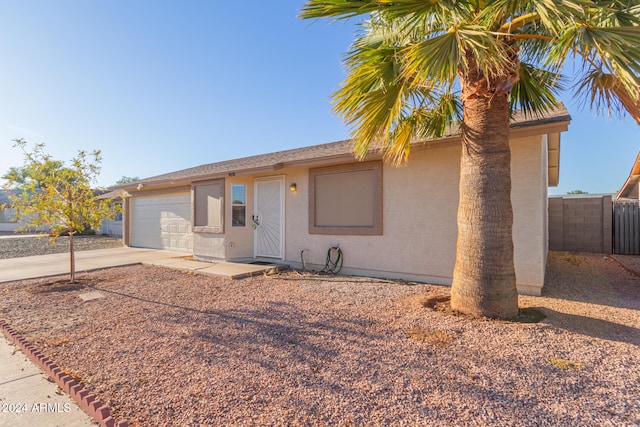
left=112, top=106, right=570, bottom=295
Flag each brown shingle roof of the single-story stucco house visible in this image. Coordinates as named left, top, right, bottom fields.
left=117, top=104, right=571, bottom=189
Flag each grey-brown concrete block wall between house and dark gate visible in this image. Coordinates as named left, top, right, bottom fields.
left=549, top=195, right=613, bottom=254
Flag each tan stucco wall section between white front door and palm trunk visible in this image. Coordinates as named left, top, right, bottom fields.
left=285, top=145, right=460, bottom=284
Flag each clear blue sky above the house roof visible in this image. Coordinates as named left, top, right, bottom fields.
left=0, top=0, right=640, bottom=194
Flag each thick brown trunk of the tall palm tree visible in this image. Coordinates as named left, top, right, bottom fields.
left=451, top=88, right=518, bottom=318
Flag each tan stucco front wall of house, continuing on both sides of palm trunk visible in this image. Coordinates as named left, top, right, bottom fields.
left=194, top=136, right=547, bottom=294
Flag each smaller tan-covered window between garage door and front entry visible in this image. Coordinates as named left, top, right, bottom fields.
left=193, top=180, right=224, bottom=233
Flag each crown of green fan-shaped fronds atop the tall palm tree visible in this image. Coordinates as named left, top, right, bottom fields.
left=301, top=0, right=640, bottom=169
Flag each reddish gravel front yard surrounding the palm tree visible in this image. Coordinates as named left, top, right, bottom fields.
left=0, top=253, right=640, bottom=426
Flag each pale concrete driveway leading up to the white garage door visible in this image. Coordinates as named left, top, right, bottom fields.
left=0, top=247, right=188, bottom=283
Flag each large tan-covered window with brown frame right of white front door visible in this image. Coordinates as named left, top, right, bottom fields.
left=309, top=162, right=382, bottom=235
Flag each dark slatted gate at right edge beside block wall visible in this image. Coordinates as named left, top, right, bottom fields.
left=613, top=201, right=640, bottom=255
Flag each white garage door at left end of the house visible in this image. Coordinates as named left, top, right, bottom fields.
left=131, top=193, right=193, bottom=252
